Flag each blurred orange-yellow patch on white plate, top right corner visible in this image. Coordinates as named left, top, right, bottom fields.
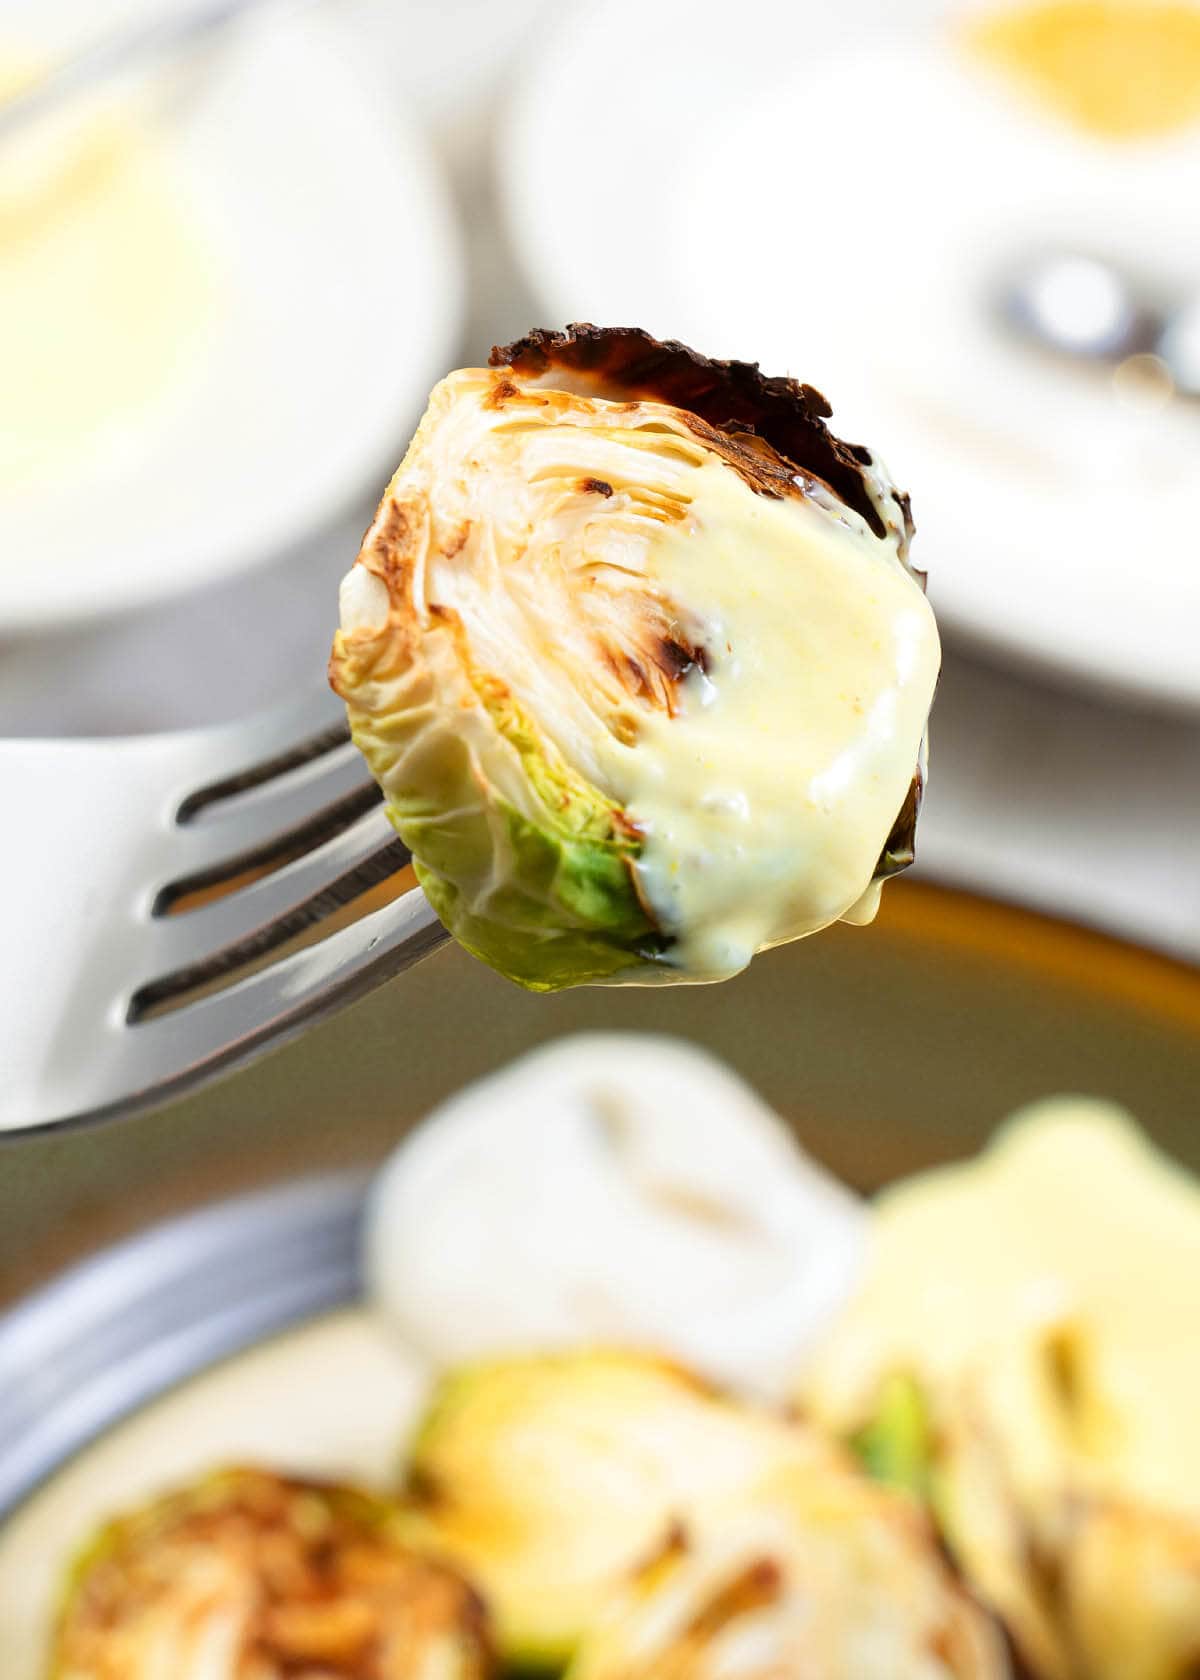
left=968, top=0, right=1200, bottom=139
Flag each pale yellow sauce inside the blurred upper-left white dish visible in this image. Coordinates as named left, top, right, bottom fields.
left=0, top=62, right=212, bottom=492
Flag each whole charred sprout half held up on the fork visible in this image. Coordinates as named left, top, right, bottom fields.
left=329, top=326, right=939, bottom=991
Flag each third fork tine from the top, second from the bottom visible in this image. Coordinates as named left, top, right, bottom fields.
left=138, top=805, right=397, bottom=981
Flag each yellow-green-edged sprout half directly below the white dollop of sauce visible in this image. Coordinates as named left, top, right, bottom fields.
left=396, top=1352, right=830, bottom=1667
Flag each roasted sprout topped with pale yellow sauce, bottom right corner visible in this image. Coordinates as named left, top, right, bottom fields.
left=802, top=1099, right=1200, bottom=1680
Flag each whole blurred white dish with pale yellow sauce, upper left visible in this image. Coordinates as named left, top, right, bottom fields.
left=0, top=0, right=461, bottom=633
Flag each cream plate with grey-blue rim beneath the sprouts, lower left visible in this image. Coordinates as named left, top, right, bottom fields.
left=0, top=1173, right=427, bottom=1680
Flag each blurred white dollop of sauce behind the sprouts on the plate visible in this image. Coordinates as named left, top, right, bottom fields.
left=365, top=1033, right=867, bottom=1401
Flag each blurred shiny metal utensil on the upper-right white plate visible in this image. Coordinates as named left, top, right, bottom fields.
left=1000, top=252, right=1200, bottom=396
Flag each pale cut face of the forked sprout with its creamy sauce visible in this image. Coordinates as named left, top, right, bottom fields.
left=359, top=370, right=939, bottom=979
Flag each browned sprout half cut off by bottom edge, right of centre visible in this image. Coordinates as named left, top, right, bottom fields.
left=568, top=1463, right=1008, bottom=1680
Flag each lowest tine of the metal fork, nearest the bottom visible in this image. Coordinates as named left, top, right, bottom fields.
left=119, top=889, right=450, bottom=1112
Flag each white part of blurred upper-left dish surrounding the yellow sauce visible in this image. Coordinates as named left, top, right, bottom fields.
left=0, top=0, right=462, bottom=632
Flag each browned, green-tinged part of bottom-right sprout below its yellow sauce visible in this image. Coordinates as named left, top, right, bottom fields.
left=847, top=1352, right=1200, bottom=1680
